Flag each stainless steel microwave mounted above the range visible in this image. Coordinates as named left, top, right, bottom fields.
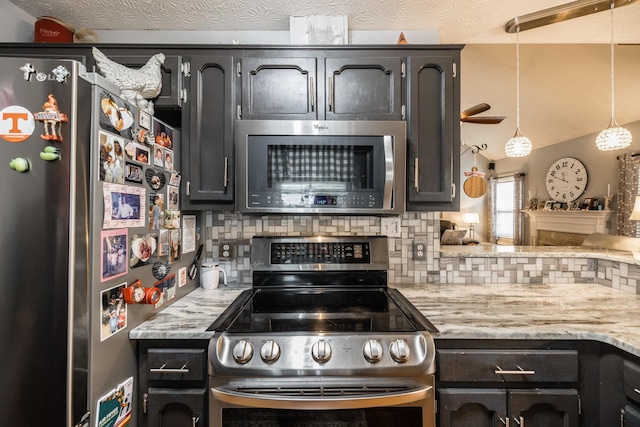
left=235, top=120, right=407, bottom=214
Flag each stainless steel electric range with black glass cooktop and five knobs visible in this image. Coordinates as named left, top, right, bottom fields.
left=209, top=236, right=437, bottom=427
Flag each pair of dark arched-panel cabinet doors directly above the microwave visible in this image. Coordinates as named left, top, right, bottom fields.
left=238, top=50, right=404, bottom=120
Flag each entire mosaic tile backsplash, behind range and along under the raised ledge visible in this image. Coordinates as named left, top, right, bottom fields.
left=205, top=212, right=640, bottom=295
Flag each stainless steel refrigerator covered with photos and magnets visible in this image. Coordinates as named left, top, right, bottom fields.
left=0, top=57, right=197, bottom=427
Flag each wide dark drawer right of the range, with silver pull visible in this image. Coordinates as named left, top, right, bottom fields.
left=438, top=350, right=578, bottom=383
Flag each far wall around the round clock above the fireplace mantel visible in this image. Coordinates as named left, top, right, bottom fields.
left=496, top=117, right=640, bottom=245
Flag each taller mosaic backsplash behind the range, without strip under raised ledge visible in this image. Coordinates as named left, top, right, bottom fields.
left=205, top=212, right=440, bottom=286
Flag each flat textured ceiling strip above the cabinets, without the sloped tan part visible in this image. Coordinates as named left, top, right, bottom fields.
left=10, top=0, right=640, bottom=43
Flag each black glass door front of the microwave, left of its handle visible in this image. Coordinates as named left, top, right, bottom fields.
left=246, top=135, right=385, bottom=211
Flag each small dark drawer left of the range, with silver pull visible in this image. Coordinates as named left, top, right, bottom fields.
left=147, top=348, right=207, bottom=381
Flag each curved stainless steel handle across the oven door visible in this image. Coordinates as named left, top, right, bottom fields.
left=211, top=386, right=433, bottom=410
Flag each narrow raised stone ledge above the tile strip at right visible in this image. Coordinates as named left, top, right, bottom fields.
left=440, top=243, right=640, bottom=264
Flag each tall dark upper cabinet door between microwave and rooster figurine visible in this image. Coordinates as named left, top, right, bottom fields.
left=182, top=56, right=235, bottom=209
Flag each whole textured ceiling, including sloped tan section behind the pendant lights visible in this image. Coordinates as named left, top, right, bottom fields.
left=10, top=0, right=640, bottom=159
